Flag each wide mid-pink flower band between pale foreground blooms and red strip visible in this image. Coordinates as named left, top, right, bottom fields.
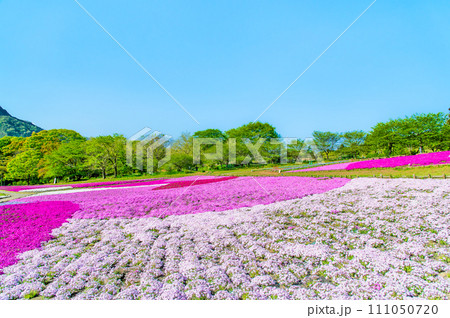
left=22, top=177, right=349, bottom=219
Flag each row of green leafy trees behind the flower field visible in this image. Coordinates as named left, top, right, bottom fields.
left=0, top=113, right=450, bottom=184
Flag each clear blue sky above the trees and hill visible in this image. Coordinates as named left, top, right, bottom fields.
left=0, top=0, right=450, bottom=138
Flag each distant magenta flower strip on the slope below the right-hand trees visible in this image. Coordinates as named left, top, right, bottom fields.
left=289, top=151, right=450, bottom=172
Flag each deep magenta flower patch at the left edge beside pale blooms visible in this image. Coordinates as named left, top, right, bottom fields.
left=0, top=201, right=79, bottom=273
